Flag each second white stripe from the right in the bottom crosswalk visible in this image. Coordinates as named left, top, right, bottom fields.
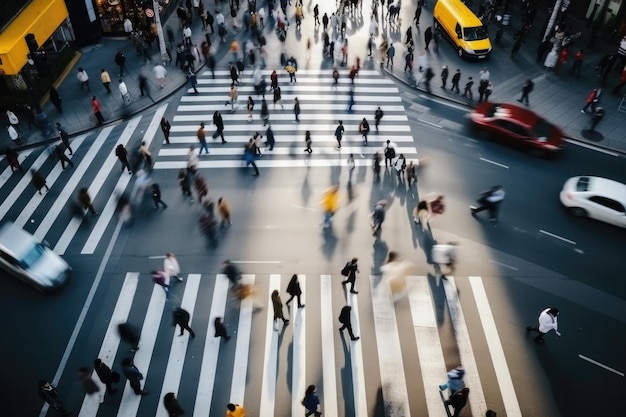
left=442, top=276, right=487, bottom=416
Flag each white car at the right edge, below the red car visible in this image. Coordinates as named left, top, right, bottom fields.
left=560, top=176, right=626, bottom=227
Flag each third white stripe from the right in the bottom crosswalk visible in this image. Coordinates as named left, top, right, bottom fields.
left=406, top=276, right=447, bottom=417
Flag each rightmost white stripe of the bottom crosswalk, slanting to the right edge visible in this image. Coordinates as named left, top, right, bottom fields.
left=468, top=276, right=522, bottom=417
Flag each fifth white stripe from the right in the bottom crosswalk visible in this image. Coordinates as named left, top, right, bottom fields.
left=345, top=293, right=369, bottom=416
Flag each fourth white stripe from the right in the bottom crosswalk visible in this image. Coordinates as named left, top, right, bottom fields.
left=369, top=276, right=411, bottom=417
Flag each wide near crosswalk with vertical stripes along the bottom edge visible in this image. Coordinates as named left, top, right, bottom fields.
left=62, top=272, right=521, bottom=417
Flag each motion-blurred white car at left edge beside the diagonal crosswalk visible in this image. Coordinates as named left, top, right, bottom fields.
left=0, top=222, right=72, bottom=291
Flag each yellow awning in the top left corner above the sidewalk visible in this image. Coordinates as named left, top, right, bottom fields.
left=0, top=0, right=68, bottom=75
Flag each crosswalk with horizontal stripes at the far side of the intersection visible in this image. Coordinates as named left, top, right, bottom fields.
left=155, top=69, right=417, bottom=169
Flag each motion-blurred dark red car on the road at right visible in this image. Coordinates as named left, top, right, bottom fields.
left=469, top=103, right=565, bottom=156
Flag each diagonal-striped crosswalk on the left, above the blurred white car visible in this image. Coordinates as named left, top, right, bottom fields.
left=0, top=104, right=168, bottom=255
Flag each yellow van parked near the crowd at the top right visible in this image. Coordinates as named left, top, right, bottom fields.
left=433, top=0, right=491, bottom=59
